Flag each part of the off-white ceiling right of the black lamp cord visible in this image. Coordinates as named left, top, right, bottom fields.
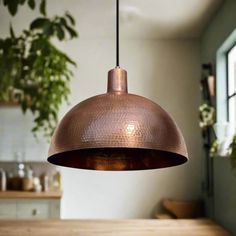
left=118, top=0, right=223, bottom=38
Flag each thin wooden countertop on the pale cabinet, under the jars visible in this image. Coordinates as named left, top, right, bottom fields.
left=0, top=191, right=62, bottom=199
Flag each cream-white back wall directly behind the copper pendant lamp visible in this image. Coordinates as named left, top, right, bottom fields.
left=0, top=1, right=201, bottom=218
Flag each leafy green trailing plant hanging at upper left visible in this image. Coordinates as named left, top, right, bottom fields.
left=0, top=0, right=78, bottom=136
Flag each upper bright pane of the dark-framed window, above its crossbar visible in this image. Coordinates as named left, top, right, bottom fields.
left=228, top=46, right=236, bottom=96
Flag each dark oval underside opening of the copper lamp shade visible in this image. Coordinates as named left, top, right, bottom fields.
left=47, top=147, right=188, bottom=171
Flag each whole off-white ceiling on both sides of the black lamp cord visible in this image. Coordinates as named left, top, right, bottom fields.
left=56, top=0, right=224, bottom=38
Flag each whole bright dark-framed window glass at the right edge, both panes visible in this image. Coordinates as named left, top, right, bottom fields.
left=227, top=45, right=236, bottom=127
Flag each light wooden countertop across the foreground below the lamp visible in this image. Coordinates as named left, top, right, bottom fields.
left=0, top=219, right=230, bottom=236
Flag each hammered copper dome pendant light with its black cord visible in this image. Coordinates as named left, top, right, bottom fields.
left=48, top=0, right=188, bottom=170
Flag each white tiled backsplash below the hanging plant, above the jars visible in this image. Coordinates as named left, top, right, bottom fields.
left=0, top=107, right=49, bottom=162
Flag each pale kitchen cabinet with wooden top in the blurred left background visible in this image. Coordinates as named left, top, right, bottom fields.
left=0, top=192, right=60, bottom=219
